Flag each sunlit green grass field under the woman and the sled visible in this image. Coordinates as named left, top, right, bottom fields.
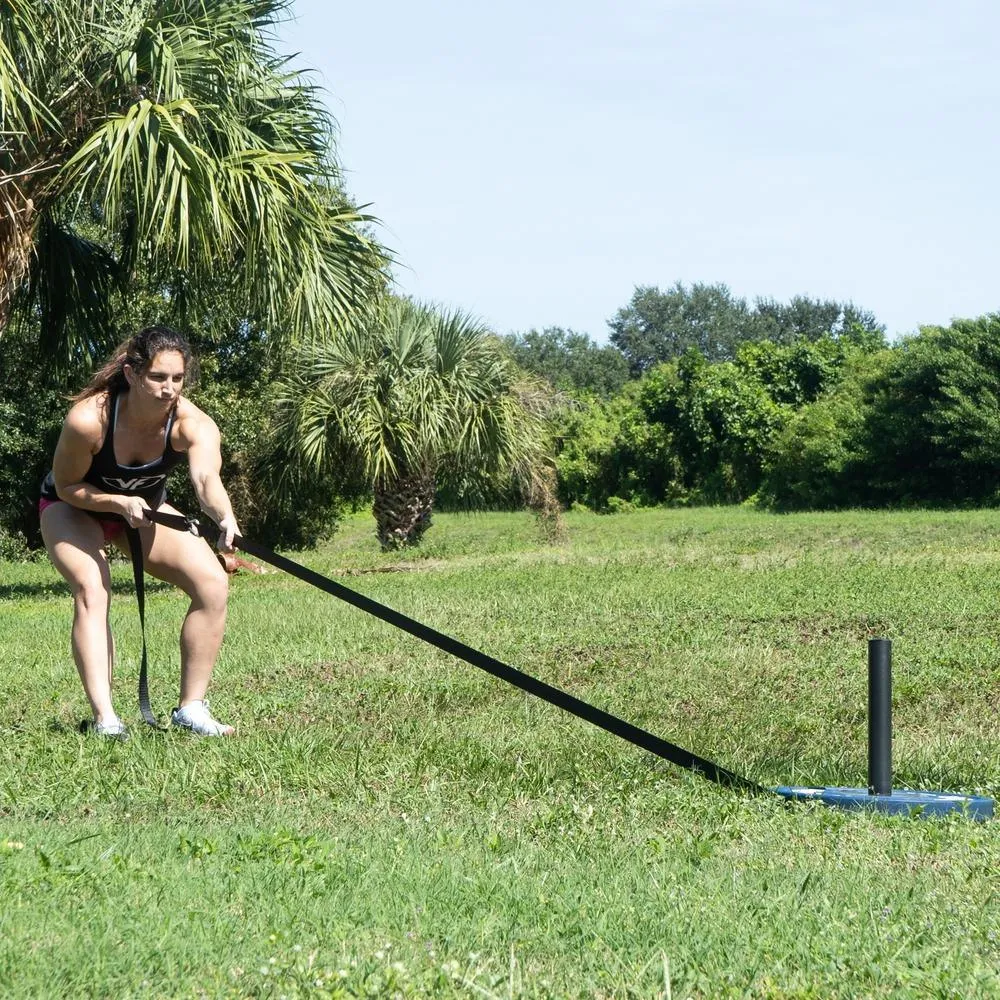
left=0, top=509, right=1000, bottom=998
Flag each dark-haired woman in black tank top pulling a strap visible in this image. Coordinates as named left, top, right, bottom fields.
left=39, top=326, right=239, bottom=739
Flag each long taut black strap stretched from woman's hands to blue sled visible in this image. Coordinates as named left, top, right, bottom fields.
left=146, top=510, right=766, bottom=792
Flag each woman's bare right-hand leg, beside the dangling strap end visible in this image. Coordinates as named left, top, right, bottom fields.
left=122, top=504, right=229, bottom=707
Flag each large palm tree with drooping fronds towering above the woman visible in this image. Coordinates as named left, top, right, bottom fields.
left=0, top=0, right=386, bottom=354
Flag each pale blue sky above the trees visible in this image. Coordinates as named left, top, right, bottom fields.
left=280, top=0, right=1000, bottom=341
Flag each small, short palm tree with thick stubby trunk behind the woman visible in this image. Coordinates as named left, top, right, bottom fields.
left=279, top=299, right=553, bottom=549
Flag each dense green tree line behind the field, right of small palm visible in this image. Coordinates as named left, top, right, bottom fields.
left=508, top=284, right=1000, bottom=511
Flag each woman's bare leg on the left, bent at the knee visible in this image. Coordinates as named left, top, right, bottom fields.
left=41, top=503, right=116, bottom=724
